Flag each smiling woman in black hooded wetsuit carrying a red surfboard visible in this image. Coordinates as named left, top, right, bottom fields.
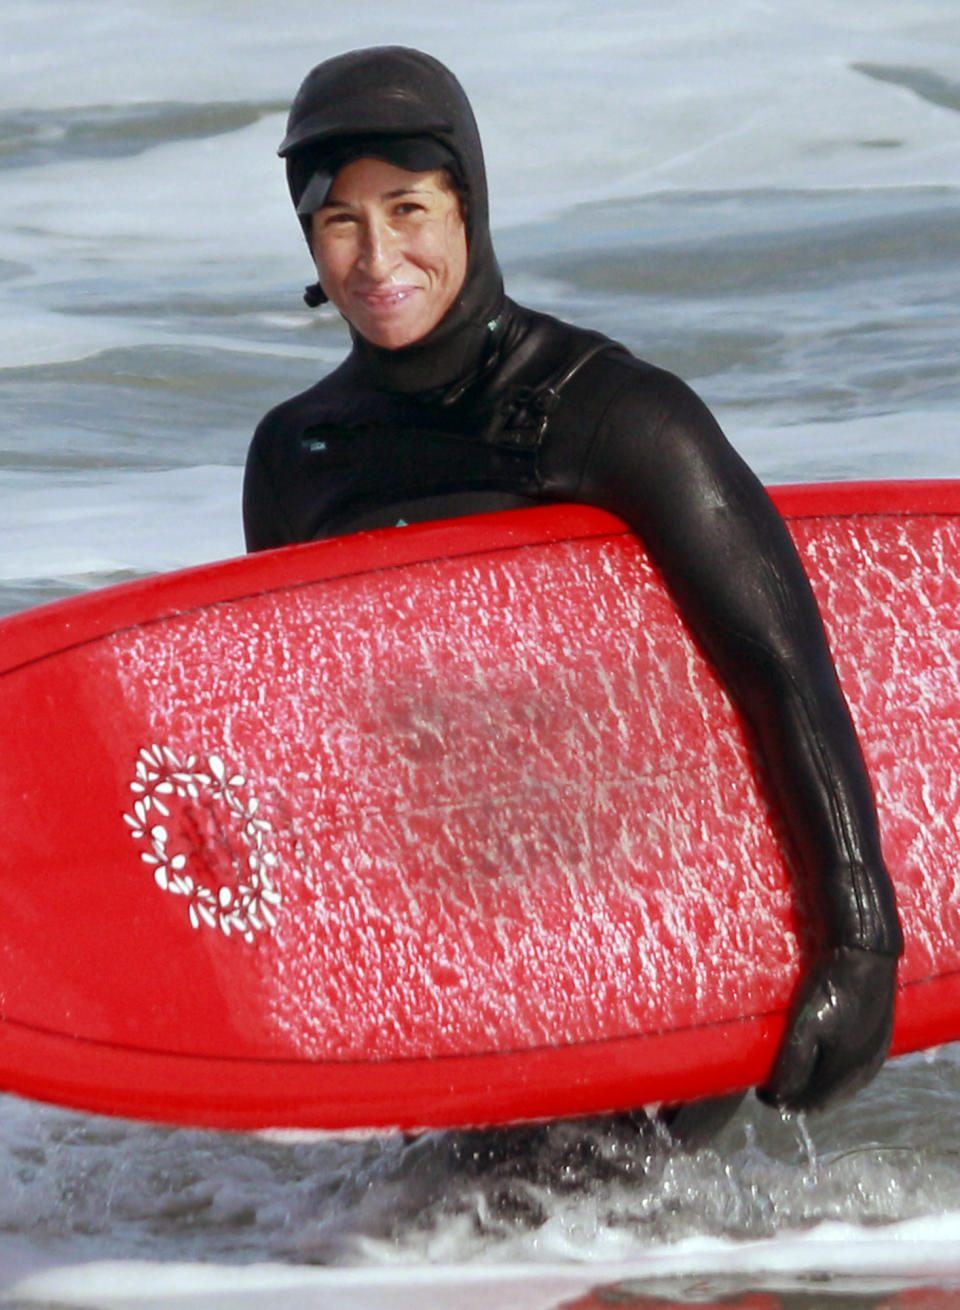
left=244, top=47, right=902, bottom=1110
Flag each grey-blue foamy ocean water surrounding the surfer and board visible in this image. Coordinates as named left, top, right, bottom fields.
left=0, top=0, right=960, bottom=1310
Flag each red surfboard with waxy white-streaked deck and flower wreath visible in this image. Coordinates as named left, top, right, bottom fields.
left=0, top=483, right=960, bottom=1132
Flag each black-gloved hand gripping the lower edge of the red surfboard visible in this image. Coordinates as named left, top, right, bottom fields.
left=757, top=946, right=897, bottom=1110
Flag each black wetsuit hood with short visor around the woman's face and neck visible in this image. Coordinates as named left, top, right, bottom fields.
left=279, top=46, right=503, bottom=392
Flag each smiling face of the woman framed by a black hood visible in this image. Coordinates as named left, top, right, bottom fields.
left=310, top=159, right=466, bottom=350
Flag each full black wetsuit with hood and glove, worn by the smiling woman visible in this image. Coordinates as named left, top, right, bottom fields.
left=244, top=48, right=902, bottom=1104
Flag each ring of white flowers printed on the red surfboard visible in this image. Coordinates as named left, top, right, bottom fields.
left=123, top=745, right=282, bottom=942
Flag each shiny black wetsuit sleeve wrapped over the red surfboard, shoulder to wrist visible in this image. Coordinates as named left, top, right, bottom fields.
left=583, top=371, right=902, bottom=956
